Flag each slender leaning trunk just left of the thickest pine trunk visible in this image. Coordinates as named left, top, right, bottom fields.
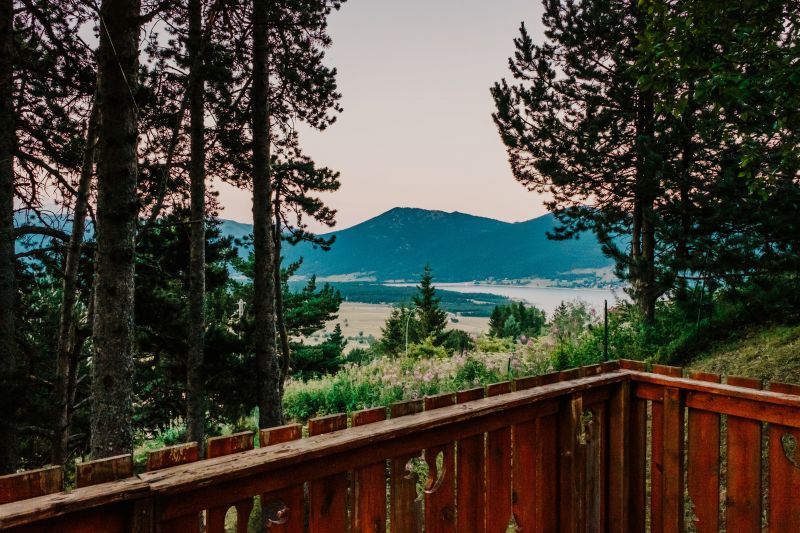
left=51, top=102, right=97, bottom=465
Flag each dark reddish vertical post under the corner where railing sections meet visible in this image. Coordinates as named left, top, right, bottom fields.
left=608, top=382, right=633, bottom=533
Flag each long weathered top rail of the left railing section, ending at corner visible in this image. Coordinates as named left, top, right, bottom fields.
left=0, top=370, right=627, bottom=528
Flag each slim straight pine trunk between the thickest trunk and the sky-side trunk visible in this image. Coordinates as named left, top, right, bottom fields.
left=186, top=0, right=206, bottom=456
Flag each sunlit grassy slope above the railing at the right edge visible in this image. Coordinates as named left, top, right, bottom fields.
left=687, top=325, right=800, bottom=383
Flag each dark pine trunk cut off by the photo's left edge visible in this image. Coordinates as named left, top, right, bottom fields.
left=0, top=0, right=17, bottom=474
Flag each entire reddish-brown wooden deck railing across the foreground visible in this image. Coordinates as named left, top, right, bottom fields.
left=0, top=361, right=800, bottom=533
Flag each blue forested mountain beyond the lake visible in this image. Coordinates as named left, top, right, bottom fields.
left=222, top=207, right=611, bottom=282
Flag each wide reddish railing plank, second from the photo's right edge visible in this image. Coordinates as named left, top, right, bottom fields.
left=725, top=377, right=761, bottom=533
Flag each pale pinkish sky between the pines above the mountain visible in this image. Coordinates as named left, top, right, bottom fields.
left=215, top=0, right=545, bottom=229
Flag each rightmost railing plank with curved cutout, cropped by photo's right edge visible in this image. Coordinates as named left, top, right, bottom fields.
left=768, top=383, right=800, bottom=531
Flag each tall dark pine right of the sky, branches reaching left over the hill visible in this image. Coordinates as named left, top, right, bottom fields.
left=492, top=0, right=672, bottom=320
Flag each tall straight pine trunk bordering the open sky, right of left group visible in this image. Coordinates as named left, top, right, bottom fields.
left=251, top=0, right=283, bottom=428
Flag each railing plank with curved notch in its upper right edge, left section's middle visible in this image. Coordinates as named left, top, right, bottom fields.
left=389, top=400, right=423, bottom=533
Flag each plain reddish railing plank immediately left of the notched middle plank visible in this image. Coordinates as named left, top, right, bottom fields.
left=352, top=407, right=386, bottom=533
